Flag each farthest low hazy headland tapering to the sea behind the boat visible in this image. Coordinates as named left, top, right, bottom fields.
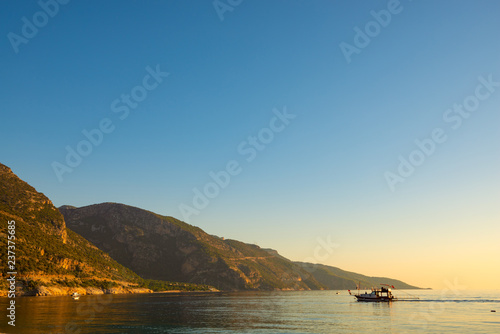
left=295, top=262, right=420, bottom=290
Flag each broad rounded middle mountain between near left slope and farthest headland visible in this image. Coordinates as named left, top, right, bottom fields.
left=59, top=203, right=323, bottom=290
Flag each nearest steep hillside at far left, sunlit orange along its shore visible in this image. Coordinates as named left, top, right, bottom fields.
left=0, top=164, right=147, bottom=294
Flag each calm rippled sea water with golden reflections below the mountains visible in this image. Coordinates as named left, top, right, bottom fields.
left=0, top=290, right=500, bottom=334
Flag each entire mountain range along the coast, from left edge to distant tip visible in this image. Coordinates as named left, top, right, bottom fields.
left=0, top=164, right=418, bottom=295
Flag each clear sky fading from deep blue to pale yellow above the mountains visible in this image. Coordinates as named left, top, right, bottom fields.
left=0, top=0, right=500, bottom=288
